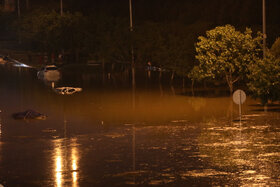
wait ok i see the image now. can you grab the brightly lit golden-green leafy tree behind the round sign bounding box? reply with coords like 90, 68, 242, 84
191, 25, 262, 93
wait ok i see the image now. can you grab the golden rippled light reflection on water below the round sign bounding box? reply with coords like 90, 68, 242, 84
198, 122, 280, 185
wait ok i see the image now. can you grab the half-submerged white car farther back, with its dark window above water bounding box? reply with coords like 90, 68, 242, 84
37, 65, 60, 82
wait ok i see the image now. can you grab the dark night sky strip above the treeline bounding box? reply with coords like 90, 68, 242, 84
30, 0, 280, 25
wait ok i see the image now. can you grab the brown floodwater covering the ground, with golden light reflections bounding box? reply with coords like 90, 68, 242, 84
0, 67, 280, 187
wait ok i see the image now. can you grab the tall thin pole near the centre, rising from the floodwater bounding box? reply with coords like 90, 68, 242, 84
129, 0, 135, 109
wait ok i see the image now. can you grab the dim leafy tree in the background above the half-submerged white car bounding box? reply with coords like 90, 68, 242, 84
21, 11, 85, 59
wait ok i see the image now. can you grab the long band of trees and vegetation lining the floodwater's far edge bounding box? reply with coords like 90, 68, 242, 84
0, 0, 280, 103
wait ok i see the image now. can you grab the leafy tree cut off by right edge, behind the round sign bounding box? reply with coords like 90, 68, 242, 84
247, 52, 280, 104
